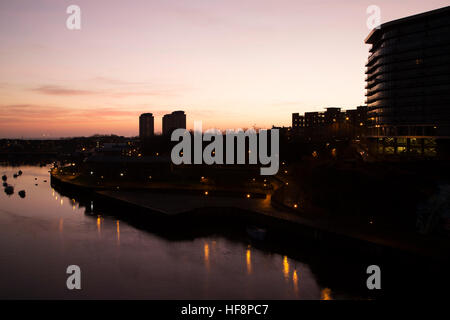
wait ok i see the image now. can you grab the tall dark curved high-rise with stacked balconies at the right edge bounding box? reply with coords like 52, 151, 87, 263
365, 7, 450, 156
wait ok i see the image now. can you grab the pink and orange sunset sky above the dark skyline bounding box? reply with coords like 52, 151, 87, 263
0, 0, 449, 138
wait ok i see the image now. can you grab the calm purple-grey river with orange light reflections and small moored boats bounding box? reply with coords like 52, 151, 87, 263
0, 166, 338, 299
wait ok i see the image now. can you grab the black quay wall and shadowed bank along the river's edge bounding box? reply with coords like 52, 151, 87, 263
51, 171, 449, 300
